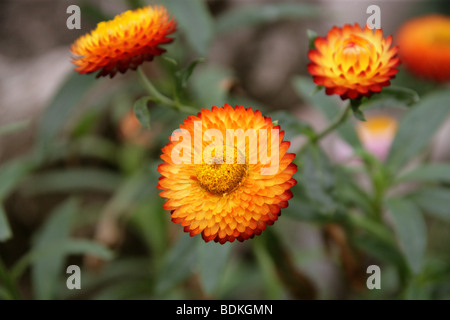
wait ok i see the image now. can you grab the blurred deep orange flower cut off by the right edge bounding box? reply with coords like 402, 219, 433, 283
397, 14, 450, 82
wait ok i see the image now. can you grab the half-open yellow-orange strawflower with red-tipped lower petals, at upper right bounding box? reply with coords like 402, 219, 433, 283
308, 24, 400, 100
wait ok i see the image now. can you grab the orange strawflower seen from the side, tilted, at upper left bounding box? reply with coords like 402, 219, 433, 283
71, 6, 176, 78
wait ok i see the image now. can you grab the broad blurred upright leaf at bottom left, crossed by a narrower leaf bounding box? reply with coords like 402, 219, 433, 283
32, 199, 79, 299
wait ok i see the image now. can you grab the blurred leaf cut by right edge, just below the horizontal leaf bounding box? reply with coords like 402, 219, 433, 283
411, 187, 450, 221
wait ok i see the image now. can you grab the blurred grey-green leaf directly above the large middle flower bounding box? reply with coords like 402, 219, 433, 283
192, 66, 231, 108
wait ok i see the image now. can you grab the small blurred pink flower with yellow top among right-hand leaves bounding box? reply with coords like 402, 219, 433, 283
356, 114, 398, 160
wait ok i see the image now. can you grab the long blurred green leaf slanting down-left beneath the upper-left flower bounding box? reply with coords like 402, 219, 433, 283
37, 72, 98, 147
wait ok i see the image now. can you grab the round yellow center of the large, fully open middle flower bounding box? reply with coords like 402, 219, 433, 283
195, 145, 248, 195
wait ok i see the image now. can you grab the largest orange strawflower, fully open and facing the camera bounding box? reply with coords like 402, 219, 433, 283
158, 104, 297, 244
